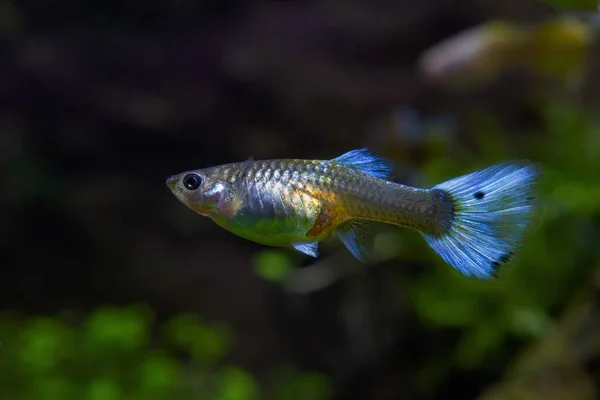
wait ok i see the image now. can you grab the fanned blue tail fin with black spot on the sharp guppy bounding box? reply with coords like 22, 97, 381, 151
423, 162, 540, 279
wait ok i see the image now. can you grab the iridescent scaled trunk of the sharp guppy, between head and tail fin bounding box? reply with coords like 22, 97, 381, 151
207, 160, 447, 242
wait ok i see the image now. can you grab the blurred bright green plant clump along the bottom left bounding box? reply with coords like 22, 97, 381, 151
0, 305, 330, 400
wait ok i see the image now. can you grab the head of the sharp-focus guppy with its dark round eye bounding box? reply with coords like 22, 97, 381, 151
166, 168, 241, 217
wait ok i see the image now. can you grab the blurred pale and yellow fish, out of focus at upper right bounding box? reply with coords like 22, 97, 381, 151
419, 16, 595, 89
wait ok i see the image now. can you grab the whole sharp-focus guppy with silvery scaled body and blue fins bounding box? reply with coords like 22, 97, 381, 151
166, 149, 540, 279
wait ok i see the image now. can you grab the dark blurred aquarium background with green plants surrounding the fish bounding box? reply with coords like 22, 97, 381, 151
0, 0, 600, 400
